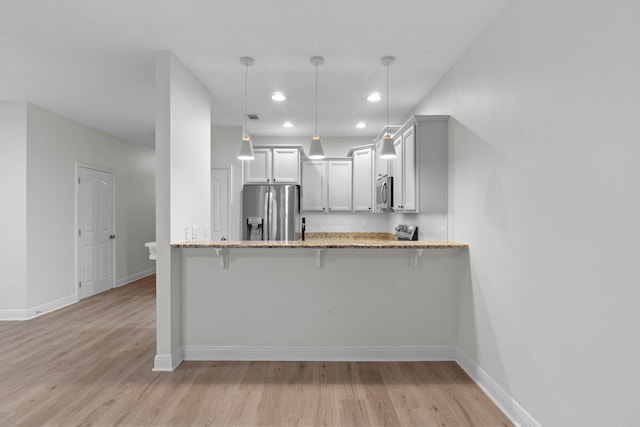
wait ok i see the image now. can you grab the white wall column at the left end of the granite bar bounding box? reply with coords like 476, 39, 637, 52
154, 52, 211, 370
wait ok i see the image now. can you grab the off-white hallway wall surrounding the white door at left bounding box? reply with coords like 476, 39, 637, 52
26, 104, 155, 307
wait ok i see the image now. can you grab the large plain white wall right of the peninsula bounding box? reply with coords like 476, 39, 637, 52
416, 0, 640, 426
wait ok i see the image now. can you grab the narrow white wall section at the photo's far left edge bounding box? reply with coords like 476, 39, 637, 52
0, 102, 27, 310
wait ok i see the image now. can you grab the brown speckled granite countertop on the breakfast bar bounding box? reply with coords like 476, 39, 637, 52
171, 232, 469, 249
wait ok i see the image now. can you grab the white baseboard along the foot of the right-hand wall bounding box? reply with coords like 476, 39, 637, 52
456, 347, 542, 427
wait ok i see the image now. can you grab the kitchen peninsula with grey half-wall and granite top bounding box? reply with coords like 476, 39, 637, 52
156, 233, 467, 370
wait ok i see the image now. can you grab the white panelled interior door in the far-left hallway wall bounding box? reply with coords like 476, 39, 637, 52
77, 166, 115, 299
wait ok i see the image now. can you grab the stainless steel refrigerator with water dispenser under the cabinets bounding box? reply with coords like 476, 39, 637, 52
242, 184, 300, 241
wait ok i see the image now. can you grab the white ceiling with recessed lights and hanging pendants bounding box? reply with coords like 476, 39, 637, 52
0, 0, 509, 147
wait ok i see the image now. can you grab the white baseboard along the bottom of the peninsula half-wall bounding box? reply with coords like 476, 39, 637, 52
183, 346, 456, 362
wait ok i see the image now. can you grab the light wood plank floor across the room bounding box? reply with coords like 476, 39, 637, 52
0, 276, 513, 427
